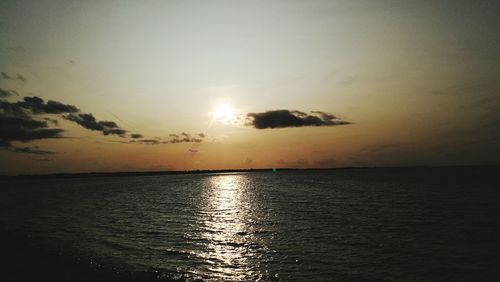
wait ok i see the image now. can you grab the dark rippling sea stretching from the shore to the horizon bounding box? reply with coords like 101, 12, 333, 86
0, 167, 500, 281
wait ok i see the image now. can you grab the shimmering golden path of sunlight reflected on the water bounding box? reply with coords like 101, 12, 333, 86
193, 174, 263, 281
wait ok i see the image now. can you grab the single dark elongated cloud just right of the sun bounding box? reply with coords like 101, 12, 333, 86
247, 110, 350, 129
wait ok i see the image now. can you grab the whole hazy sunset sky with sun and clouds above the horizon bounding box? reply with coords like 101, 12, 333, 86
0, 0, 500, 175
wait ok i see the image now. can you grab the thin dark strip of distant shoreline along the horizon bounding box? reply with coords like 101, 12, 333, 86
0, 165, 500, 180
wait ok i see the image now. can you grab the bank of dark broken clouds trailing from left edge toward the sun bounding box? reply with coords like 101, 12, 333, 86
0, 92, 206, 154
